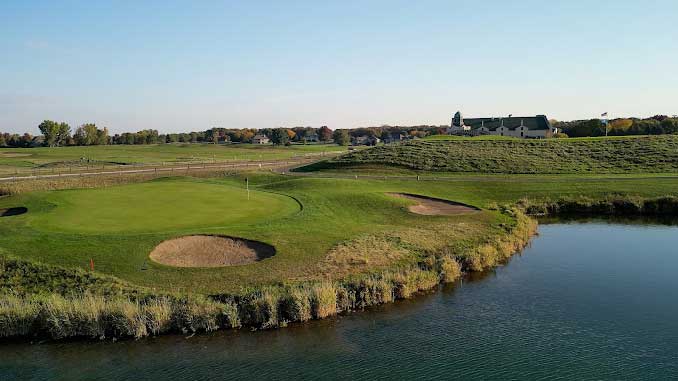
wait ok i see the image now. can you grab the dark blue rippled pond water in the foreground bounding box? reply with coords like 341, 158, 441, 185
0, 222, 678, 380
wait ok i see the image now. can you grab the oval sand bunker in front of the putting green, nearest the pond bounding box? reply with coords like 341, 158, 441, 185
150, 235, 275, 267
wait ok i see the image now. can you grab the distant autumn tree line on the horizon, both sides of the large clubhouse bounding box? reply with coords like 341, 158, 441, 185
0, 115, 678, 147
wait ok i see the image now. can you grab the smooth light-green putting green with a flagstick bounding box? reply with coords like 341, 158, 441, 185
31, 180, 299, 233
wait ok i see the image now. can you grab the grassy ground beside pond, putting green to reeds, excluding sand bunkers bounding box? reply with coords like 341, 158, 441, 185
0, 169, 678, 338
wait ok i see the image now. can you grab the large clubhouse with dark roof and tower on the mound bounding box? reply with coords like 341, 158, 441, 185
447, 111, 558, 139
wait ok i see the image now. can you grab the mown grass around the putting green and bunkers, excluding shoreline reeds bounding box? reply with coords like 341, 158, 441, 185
0, 173, 678, 293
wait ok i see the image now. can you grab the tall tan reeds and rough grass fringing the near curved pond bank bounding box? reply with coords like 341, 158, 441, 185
0, 206, 536, 339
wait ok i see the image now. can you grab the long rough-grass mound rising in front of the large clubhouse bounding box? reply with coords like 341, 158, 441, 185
302, 135, 678, 174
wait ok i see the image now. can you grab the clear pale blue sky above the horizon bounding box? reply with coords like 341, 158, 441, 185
0, 0, 678, 133
